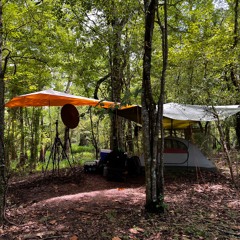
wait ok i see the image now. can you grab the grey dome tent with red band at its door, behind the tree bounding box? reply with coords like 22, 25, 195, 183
140, 137, 216, 169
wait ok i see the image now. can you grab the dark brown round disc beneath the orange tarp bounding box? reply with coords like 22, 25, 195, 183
61, 104, 79, 129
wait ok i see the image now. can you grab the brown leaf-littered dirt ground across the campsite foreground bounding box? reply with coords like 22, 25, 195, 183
0, 165, 240, 240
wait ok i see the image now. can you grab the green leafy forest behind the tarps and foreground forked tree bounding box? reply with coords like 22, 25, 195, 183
0, 0, 240, 221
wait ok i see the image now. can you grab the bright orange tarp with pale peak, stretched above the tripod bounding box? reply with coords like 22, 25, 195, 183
5, 89, 120, 108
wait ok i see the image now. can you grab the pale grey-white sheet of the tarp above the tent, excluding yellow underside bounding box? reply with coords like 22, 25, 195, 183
163, 103, 240, 121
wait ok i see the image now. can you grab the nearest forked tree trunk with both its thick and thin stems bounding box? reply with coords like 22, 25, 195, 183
142, 0, 168, 213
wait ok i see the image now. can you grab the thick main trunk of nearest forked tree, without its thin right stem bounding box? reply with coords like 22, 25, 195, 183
142, 0, 162, 212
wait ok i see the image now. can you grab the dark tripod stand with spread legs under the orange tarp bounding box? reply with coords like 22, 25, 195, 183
45, 120, 72, 174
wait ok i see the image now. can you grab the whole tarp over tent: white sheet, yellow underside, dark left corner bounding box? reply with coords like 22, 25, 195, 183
114, 103, 240, 129
